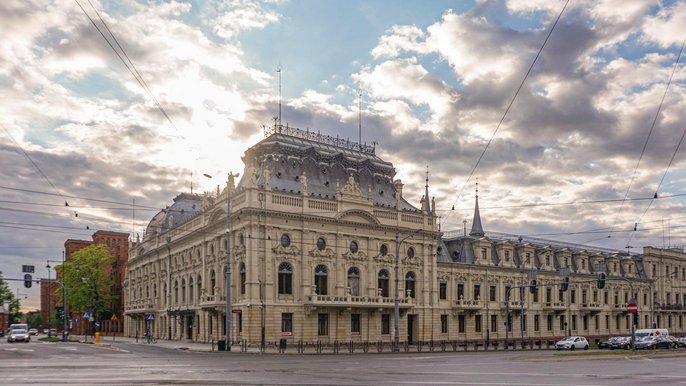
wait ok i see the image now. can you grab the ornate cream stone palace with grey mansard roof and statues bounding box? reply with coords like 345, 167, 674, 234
124, 126, 686, 345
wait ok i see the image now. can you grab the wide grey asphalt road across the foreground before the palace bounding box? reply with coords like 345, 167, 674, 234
0, 340, 686, 386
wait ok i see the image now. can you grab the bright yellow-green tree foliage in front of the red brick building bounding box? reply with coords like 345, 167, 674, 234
55, 245, 118, 320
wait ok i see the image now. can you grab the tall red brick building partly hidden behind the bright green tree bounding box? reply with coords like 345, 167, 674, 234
64, 231, 129, 335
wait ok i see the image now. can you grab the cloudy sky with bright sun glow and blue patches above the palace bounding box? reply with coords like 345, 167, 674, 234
0, 0, 686, 307
